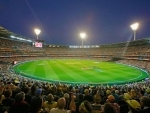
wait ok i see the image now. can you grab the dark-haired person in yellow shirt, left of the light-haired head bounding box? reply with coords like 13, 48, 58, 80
43, 94, 57, 112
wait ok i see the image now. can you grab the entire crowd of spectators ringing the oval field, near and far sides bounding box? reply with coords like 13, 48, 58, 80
0, 35, 150, 113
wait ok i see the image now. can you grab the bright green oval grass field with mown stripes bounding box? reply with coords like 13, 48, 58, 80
14, 59, 148, 84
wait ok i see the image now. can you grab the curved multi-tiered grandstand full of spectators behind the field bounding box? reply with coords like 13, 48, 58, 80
0, 26, 150, 85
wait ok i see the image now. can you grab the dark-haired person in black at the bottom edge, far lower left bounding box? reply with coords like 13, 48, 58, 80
8, 92, 30, 113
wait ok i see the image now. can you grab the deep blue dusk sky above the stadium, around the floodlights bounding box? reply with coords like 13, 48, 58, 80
0, 0, 150, 45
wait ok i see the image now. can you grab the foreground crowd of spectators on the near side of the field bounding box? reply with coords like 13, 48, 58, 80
0, 67, 150, 113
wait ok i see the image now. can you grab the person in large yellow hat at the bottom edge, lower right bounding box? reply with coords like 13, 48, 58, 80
127, 99, 141, 113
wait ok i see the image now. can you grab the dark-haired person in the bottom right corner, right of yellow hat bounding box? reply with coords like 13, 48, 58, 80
140, 96, 150, 113
